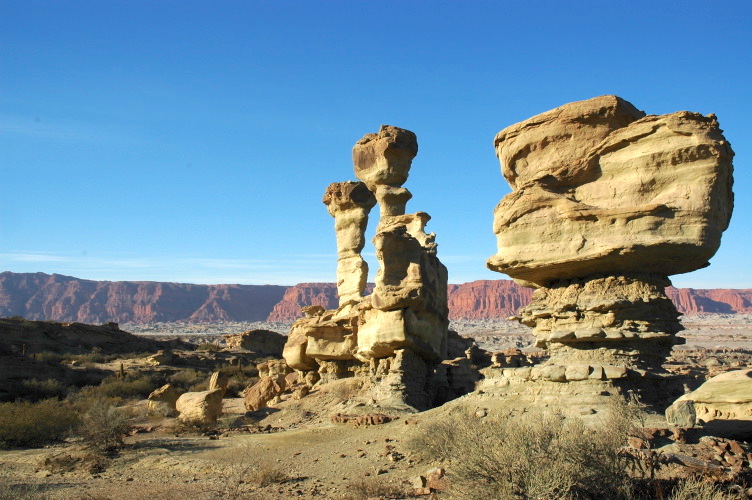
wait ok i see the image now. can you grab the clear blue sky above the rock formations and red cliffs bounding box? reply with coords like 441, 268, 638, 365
0, 0, 752, 288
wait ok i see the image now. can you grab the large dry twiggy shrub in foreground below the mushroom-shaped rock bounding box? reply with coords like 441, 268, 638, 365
410, 405, 634, 499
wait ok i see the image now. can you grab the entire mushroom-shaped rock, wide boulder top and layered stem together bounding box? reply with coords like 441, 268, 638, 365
488, 96, 734, 408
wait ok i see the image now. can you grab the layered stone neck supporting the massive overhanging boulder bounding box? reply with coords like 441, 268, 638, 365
519, 274, 683, 367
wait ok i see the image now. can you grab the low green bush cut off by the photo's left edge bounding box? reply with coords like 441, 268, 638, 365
0, 399, 79, 447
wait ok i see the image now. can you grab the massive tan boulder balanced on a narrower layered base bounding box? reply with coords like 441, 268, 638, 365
488, 96, 734, 285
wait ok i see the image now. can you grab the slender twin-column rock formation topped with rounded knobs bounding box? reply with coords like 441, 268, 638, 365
284, 125, 458, 409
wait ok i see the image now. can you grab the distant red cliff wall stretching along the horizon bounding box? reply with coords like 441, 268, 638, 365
0, 272, 752, 323
